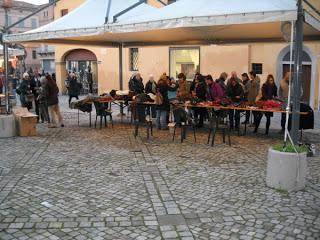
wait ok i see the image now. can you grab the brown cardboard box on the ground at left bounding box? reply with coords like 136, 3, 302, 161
12, 107, 38, 137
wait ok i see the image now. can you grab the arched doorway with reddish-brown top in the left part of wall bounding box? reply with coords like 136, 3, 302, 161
64, 49, 98, 94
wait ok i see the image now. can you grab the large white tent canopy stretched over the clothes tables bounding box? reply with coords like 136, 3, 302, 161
5, 0, 320, 46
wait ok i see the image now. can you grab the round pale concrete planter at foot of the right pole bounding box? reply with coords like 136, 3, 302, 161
266, 148, 307, 192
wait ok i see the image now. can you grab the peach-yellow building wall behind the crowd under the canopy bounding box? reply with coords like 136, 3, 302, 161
55, 0, 320, 109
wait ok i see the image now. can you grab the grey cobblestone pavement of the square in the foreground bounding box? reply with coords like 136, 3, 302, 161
0, 96, 320, 240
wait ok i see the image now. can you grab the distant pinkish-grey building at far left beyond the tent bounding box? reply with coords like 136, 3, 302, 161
0, 0, 54, 71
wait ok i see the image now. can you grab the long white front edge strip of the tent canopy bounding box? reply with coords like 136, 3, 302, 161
4, 10, 297, 42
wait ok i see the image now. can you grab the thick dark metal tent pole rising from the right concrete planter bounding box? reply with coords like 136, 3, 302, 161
291, 0, 304, 144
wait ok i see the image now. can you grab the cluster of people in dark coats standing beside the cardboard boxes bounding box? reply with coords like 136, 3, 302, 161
16, 72, 64, 128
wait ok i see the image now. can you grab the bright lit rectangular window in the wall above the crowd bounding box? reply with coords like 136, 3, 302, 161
170, 48, 200, 80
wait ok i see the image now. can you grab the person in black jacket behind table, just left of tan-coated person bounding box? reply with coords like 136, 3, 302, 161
226, 78, 244, 131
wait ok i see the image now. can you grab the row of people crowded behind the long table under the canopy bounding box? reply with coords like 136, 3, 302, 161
129, 71, 290, 134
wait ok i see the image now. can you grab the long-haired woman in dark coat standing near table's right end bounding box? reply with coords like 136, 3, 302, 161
254, 74, 278, 135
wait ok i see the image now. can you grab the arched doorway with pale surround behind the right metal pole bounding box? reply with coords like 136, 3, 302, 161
277, 46, 317, 107
